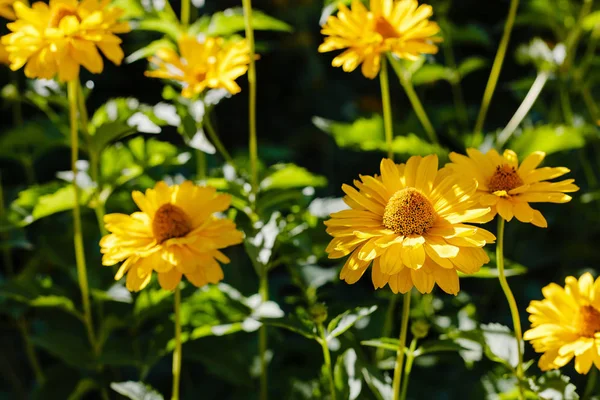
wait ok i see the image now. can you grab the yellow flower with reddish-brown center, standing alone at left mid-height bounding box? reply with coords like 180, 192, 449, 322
100, 181, 242, 291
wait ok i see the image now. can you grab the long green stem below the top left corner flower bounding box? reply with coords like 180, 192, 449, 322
68, 80, 98, 353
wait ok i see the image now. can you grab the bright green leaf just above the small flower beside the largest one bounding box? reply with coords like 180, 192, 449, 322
510, 125, 595, 157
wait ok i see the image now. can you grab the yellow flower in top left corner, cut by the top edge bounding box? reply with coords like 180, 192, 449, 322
2, 0, 130, 82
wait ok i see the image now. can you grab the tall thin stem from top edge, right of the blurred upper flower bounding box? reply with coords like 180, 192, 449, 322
242, 0, 258, 194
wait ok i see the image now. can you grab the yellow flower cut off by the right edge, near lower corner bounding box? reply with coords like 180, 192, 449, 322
524, 272, 600, 374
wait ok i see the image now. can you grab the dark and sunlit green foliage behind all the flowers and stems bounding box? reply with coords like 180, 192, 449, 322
0, 0, 600, 399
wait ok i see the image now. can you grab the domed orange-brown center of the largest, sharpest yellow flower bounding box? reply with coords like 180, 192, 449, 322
383, 188, 436, 236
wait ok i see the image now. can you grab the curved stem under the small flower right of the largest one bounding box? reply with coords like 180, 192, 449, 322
496, 216, 525, 400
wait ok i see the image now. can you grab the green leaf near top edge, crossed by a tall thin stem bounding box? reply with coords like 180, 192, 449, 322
206, 7, 292, 36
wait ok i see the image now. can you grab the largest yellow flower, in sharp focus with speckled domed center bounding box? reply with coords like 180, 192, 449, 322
325, 155, 495, 294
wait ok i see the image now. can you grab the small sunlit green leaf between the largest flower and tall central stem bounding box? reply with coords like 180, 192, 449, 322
260, 164, 327, 191
